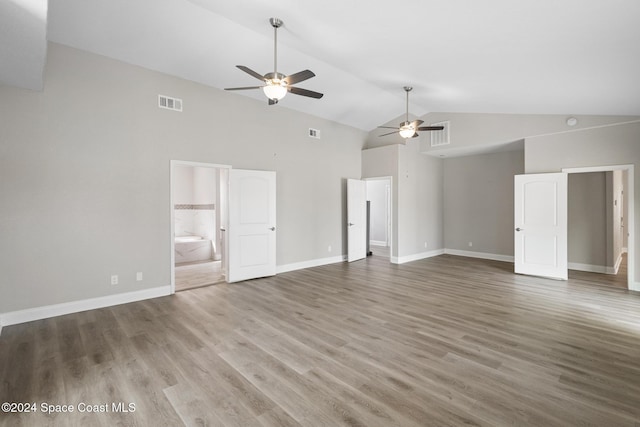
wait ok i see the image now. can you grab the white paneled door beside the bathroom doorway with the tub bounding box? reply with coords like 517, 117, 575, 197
227, 169, 276, 282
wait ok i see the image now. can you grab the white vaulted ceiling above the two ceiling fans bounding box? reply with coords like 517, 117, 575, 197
10, 0, 640, 130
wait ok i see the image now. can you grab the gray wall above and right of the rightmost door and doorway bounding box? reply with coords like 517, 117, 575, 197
525, 123, 640, 287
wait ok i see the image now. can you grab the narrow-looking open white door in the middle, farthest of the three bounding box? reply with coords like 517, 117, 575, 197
347, 179, 367, 262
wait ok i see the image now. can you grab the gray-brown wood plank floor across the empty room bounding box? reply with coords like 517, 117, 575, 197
0, 255, 640, 427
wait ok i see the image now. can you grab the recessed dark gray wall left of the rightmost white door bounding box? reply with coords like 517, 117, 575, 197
444, 151, 524, 256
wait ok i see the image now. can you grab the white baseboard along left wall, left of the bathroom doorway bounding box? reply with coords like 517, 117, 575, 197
0, 286, 171, 326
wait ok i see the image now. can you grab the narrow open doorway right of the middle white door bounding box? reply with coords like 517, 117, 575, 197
364, 176, 392, 260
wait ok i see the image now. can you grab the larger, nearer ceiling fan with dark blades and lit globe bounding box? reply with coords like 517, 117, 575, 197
225, 18, 323, 105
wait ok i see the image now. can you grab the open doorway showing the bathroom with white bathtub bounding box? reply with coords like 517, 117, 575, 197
170, 160, 230, 293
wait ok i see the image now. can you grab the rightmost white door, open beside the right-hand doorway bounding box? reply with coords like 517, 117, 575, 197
514, 173, 567, 280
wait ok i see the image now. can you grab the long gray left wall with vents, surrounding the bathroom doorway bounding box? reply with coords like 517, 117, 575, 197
0, 44, 366, 313
